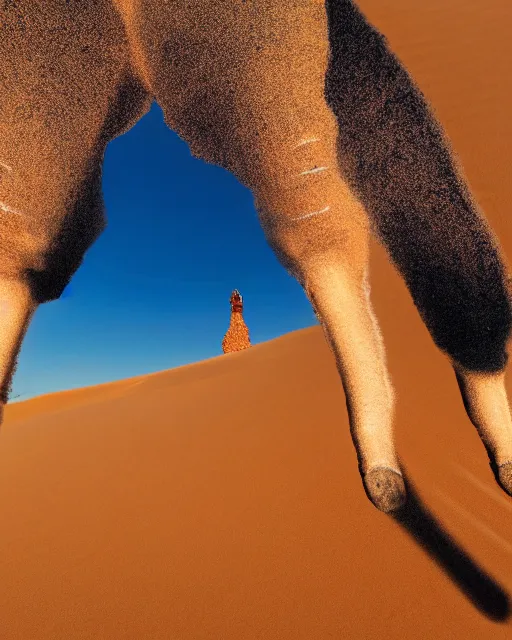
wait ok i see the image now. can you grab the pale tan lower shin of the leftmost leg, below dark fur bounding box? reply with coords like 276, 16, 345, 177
0, 279, 37, 424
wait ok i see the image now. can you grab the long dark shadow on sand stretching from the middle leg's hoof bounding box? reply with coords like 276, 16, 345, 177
391, 467, 510, 622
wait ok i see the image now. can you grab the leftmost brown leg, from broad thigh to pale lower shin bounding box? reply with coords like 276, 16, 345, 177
0, 0, 151, 430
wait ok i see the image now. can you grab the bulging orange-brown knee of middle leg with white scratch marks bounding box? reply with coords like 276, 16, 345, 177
251, 128, 369, 281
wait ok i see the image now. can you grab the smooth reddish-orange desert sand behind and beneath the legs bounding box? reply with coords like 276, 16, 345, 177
0, 0, 512, 640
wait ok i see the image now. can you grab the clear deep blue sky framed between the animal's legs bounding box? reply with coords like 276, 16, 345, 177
12, 104, 317, 401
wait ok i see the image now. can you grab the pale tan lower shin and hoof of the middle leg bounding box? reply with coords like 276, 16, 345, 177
304, 261, 405, 512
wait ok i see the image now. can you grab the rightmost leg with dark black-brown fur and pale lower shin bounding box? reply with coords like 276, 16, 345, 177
326, 0, 512, 494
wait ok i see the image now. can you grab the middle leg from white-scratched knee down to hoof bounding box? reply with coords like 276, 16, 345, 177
253, 126, 405, 512
